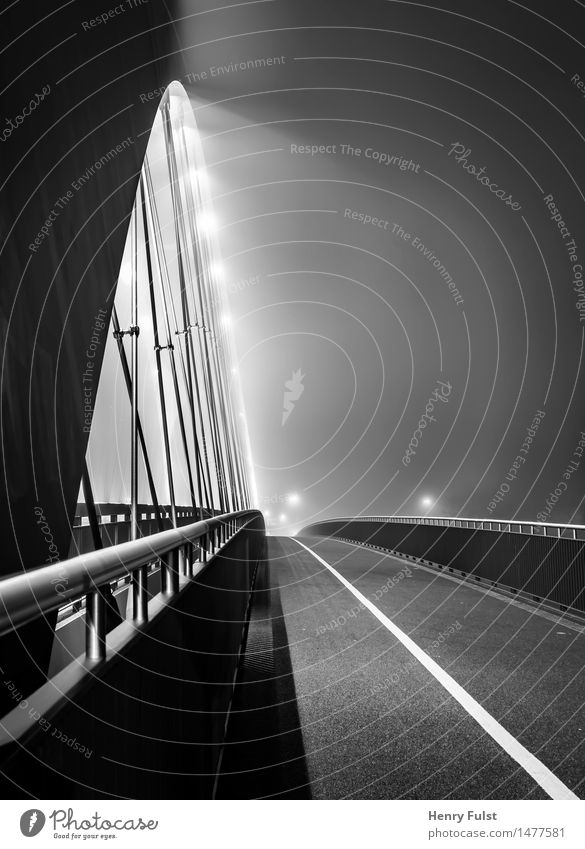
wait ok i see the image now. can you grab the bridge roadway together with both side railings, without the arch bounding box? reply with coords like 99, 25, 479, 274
0, 510, 585, 800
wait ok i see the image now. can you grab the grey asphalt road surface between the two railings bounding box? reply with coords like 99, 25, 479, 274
217, 538, 585, 799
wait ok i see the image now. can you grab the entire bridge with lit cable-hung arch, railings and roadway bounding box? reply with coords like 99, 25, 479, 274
0, 4, 585, 800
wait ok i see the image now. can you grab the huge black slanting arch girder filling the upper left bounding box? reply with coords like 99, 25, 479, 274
0, 0, 182, 708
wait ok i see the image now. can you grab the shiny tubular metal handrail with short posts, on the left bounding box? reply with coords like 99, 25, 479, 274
0, 510, 262, 660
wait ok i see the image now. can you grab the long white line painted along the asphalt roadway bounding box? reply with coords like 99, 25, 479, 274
291, 537, 579, 801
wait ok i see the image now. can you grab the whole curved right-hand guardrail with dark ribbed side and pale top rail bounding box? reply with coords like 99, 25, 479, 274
300, 516, 585, 617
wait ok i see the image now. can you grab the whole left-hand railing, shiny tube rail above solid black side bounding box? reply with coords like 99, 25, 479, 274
0, 510, 265, 799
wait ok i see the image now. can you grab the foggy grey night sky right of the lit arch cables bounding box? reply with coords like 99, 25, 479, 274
171, 0, 585, 531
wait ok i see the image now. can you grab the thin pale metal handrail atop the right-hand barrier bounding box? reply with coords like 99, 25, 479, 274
301, 516, 585, 539
